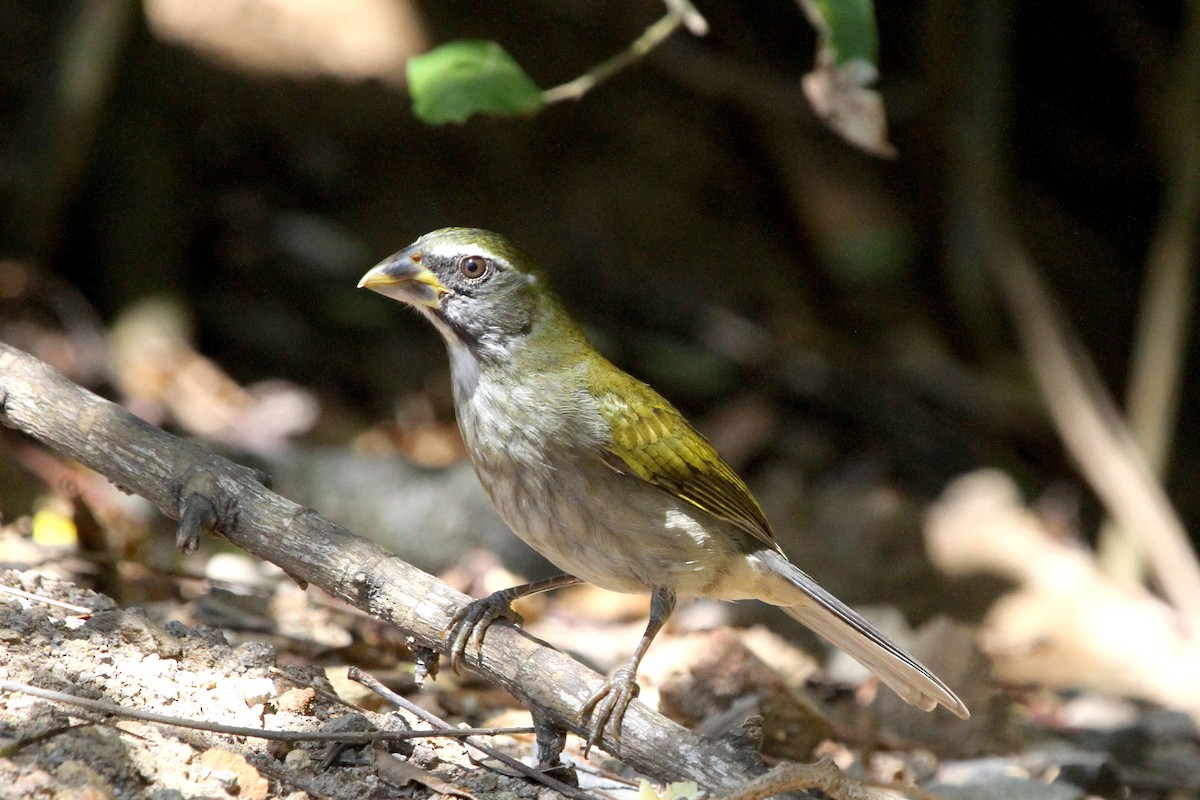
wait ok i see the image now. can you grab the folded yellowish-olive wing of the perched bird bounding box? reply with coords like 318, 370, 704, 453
598, 379, 779, 549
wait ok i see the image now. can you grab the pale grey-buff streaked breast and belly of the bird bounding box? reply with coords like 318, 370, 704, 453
456, 380, 731, 595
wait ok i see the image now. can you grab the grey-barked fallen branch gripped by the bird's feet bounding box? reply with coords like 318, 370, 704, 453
0, 343, 766, 792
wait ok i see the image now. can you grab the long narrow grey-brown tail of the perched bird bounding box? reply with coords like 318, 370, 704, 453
757, 551, 971, 720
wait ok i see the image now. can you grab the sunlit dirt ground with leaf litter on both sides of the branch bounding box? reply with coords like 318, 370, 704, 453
0, 532, 1200, 800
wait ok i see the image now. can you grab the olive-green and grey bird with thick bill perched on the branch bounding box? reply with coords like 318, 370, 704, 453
359, 228, 970, 748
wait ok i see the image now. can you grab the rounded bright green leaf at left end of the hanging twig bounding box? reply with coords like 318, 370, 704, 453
406, 40, 545, 125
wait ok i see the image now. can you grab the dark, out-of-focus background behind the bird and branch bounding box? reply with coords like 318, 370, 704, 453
0, 0, 1200, 786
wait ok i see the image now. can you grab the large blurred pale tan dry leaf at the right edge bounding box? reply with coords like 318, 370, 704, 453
925, 470, 1200, 720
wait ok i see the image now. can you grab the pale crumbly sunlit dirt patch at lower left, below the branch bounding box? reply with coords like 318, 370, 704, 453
0, 572, 573, 800
